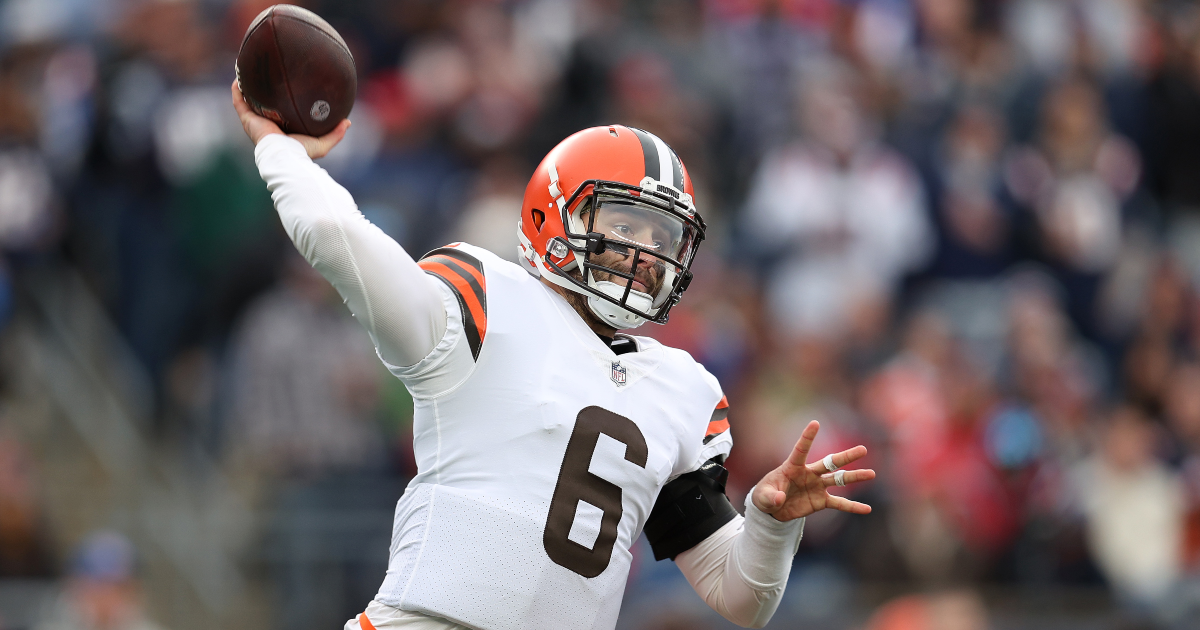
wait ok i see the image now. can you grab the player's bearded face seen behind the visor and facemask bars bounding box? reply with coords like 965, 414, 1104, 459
582, 200, 688, 296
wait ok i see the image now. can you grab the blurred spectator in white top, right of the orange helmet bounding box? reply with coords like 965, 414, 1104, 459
743, 58, 932, 340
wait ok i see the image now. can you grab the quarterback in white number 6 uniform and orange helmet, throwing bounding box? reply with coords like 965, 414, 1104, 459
233, 82, 875, 630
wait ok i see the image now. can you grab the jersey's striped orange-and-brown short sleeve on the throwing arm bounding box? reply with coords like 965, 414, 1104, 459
388, 244, 487, 398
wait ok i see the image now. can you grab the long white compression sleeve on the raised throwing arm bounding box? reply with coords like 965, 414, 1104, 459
254, 133, 446, 366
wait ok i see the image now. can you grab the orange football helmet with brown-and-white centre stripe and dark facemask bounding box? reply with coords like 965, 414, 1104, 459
517, 125, 704, 329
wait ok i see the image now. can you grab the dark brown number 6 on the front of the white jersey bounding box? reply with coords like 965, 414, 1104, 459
541, 407, 647, 577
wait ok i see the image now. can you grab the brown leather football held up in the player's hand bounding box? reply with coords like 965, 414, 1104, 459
234, 5, 358, 136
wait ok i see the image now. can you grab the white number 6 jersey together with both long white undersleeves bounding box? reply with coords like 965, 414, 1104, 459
254, 134, 804, 630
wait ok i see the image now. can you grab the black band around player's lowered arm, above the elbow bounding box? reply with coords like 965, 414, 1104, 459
646, 458, 738, 560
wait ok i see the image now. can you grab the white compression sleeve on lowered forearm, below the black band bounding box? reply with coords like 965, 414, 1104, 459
676, 497, 804, 628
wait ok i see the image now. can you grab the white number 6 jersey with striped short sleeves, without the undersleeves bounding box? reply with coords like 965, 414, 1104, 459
377, 244, 732, 630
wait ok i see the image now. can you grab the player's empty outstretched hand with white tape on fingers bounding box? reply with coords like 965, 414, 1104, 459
751, 420, 875, 521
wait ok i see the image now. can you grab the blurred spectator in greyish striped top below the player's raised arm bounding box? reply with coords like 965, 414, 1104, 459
228, 256, 382, 478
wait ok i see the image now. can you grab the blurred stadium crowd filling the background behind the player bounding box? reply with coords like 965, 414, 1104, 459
0, 0, 1200, 630
